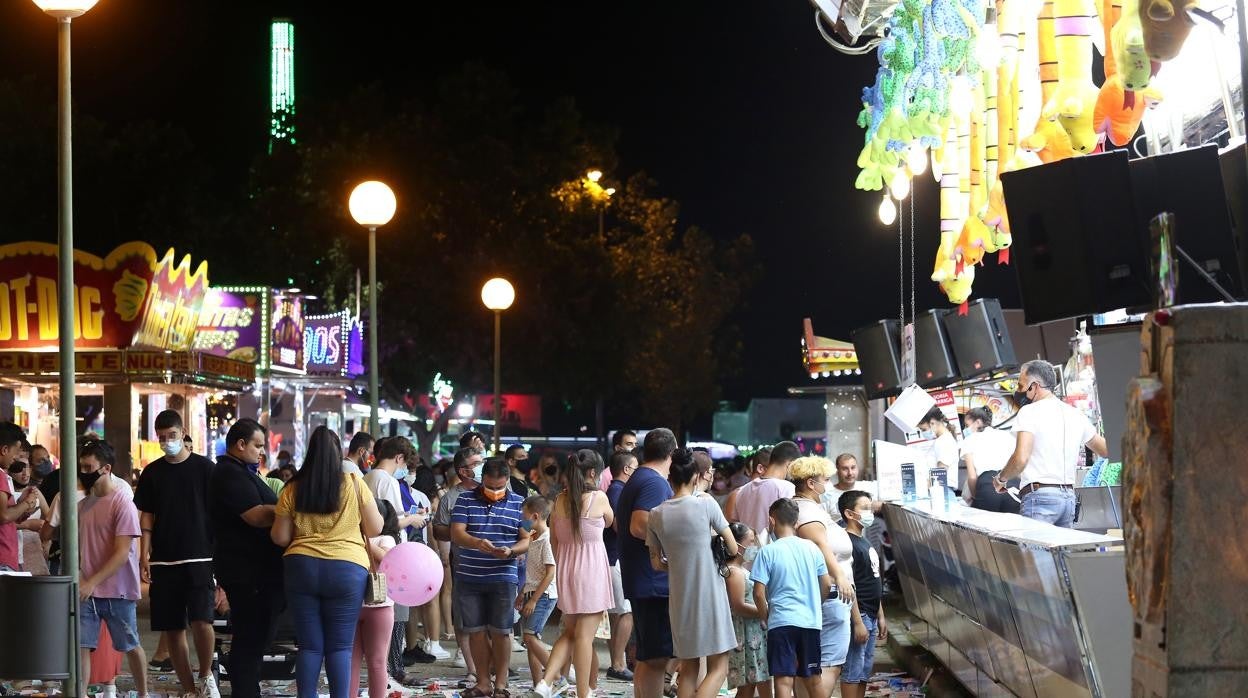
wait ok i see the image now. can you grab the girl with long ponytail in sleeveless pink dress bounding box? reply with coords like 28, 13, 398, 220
533, 448, 615, 698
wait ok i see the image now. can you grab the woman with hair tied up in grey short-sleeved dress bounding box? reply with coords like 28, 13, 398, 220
646, 448, 736, 698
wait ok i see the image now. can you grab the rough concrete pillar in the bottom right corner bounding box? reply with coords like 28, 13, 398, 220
1128, 303, 1248, 698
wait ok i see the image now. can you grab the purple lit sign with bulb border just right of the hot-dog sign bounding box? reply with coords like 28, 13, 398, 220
195, 286, 270, 368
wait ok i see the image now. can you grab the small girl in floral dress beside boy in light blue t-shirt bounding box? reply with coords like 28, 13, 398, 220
711, 523, 771, 698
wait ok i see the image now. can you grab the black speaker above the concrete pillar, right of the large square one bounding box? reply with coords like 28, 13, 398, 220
1131, 145, 1243, 303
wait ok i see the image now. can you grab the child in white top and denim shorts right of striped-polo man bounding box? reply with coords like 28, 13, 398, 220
515, 494, 559, 683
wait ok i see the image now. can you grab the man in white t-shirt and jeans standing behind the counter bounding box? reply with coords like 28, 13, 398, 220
992, 360, 1109, 528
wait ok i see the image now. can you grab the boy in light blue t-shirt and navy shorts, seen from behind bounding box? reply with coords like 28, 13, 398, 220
750, 498, 832, 698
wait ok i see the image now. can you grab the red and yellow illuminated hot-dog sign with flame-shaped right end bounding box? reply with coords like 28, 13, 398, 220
0, 242, 207, 350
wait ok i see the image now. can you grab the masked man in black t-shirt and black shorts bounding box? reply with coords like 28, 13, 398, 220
135, 410, 220, 698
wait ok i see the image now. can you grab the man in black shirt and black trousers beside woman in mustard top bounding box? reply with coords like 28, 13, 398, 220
210, 418, 286, 698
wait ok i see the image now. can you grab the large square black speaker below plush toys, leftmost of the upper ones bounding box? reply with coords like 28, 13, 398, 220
1003, 150, 1153, 324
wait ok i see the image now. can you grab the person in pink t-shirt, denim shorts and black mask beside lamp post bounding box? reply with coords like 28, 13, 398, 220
77, 440, 147, 697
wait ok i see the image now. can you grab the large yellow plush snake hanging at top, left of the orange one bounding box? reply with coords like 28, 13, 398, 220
1042, 0, 1099, 155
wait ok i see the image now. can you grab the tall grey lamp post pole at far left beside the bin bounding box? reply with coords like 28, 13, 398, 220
56, 17, 84, 696
